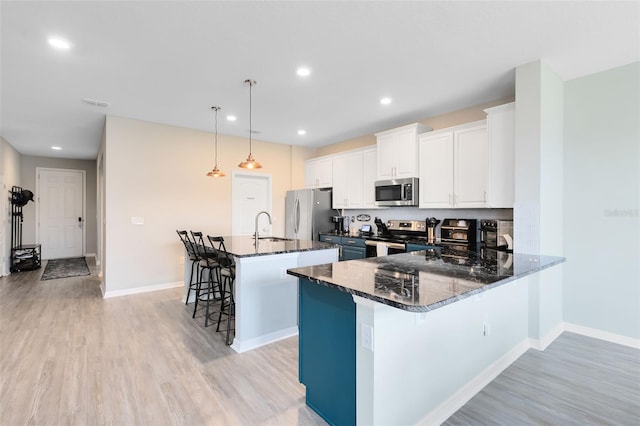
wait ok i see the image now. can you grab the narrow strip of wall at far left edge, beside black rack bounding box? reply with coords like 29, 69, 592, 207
0, 138, 21, 277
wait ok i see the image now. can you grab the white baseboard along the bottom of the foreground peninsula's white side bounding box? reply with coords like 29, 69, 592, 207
418, 339, 529, 425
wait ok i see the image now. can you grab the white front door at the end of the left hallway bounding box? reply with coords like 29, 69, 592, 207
36, 169, 84, 259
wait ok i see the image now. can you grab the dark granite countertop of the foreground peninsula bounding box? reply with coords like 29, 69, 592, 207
287, 247, 565, 312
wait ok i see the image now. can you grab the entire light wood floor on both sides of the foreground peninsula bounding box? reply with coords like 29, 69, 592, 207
0, 265, 640, 426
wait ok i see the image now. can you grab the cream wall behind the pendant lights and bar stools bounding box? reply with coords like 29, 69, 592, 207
103, 116, 312, 292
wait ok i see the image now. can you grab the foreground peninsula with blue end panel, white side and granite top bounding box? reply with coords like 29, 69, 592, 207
288, 248, 564, 425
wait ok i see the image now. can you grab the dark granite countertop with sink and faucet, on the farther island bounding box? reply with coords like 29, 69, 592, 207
224, 235, 337, 258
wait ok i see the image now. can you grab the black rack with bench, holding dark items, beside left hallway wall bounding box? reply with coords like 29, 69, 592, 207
9, 186, 42, 272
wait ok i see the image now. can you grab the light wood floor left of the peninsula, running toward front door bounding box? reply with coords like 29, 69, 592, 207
0, 260, 325, 426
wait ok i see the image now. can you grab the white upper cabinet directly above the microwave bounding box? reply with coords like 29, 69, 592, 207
376, 123, 431, 180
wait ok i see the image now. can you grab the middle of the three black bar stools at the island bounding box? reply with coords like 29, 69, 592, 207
191, 231, 222, 327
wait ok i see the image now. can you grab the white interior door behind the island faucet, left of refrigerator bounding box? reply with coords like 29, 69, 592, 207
231, 172, 271, 235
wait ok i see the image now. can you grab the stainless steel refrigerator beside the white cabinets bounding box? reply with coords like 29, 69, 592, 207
284, 189, 333, 241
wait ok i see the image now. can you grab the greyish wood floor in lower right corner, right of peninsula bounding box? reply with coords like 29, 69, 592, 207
445, 333, 640, 426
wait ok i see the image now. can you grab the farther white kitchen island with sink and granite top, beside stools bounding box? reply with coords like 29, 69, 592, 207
185, 236, 338, 352
